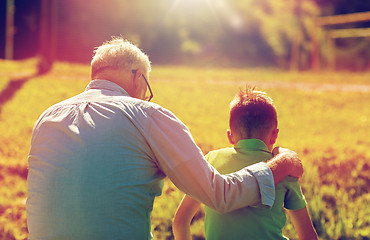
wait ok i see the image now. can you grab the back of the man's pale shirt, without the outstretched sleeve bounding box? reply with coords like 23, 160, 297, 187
27, 80, 164, 240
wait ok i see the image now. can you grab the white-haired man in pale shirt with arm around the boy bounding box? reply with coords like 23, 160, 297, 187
27, 38, 303, 240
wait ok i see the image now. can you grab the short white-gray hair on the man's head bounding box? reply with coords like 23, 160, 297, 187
91, 37, 151, 77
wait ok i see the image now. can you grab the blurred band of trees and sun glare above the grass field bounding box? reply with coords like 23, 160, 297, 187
0, 0, 370, 71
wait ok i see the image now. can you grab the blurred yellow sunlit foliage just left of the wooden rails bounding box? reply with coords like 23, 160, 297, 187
254, 0, 320, 68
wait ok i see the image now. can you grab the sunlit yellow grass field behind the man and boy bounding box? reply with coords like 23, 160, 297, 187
0, 60, 370, 240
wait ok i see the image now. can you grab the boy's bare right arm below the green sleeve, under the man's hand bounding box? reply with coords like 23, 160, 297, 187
288, 207, 318, 240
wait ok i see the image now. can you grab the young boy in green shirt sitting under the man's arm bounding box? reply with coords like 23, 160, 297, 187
172, 87, 317, 240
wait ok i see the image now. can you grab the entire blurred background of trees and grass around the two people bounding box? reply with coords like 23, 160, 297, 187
0, 0, 370, 240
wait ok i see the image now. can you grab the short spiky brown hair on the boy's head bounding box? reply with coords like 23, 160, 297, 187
229, 85, 277, 139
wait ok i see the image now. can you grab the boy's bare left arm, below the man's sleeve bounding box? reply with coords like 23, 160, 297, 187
172, 195, 200, 240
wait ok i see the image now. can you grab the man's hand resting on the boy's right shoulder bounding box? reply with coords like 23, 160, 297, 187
267, 147, 303, 184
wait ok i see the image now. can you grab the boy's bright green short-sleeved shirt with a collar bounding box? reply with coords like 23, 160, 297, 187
205, 139, 306, 240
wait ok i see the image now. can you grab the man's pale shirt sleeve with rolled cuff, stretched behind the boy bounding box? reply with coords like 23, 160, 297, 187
147, 108, 275, 213
